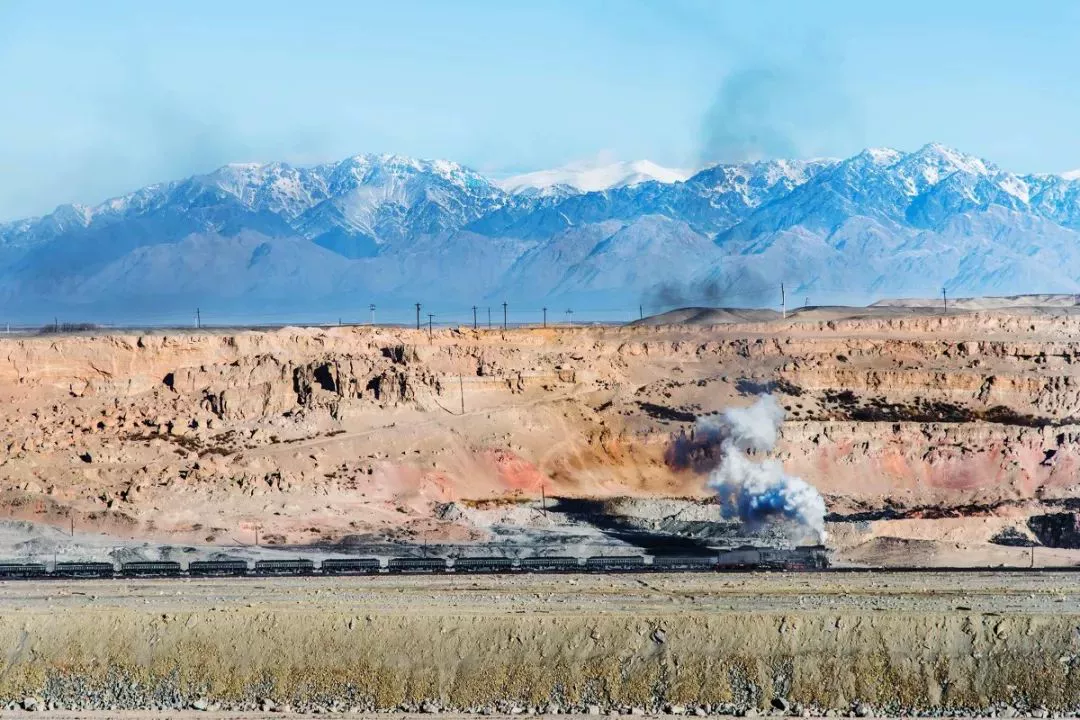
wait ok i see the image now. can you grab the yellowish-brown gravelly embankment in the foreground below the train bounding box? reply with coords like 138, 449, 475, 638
6, 573, 1080, 715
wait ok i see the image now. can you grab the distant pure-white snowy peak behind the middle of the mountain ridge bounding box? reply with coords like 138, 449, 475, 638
496, 160, 692, 192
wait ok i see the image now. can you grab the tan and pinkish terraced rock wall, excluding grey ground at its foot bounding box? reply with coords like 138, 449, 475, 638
6, 313, 1080, 548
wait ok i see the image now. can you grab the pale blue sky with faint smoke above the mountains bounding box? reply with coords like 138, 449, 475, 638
0, 0, 1080, 219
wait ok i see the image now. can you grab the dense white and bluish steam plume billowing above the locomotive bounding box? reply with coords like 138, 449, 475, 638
694, 395, 825, 543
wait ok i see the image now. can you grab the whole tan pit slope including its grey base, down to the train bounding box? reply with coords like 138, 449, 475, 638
0, 301, 1080, 566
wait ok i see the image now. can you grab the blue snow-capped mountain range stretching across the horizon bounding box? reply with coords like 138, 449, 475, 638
0, 144, 1080, 322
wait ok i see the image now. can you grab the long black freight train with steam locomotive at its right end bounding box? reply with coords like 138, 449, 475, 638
0, 545, 828, 580
